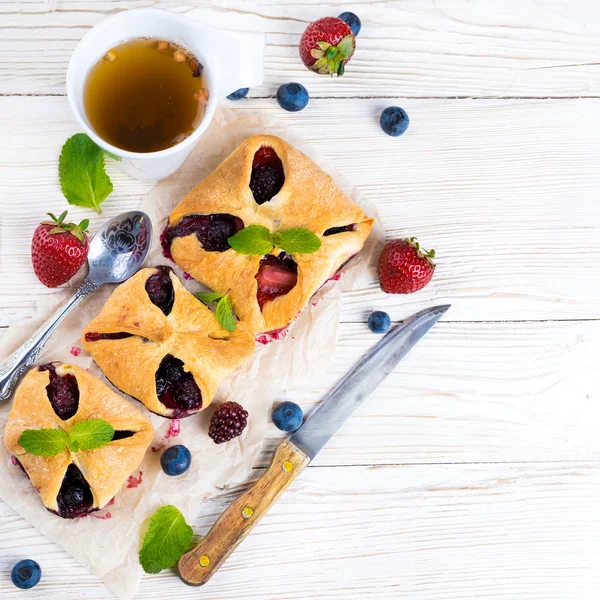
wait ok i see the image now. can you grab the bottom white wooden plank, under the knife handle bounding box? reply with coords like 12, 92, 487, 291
0, 463, 600, 600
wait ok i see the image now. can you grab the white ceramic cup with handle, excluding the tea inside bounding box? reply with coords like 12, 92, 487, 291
67, 8, 265, 182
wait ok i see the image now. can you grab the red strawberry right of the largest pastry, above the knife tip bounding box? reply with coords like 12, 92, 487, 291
377, 238, 435, 294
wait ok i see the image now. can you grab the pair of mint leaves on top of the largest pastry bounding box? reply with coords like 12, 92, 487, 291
227, 225, 321, 255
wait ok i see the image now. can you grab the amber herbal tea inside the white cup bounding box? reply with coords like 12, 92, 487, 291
84, 39, 208, 152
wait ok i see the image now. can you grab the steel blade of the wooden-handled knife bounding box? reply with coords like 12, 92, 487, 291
290, 305, 450, 460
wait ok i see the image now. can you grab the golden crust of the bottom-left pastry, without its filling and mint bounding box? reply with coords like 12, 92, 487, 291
4, 363, 154, 512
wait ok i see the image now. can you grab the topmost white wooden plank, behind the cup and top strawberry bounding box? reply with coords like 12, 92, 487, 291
0, 0, 600, 97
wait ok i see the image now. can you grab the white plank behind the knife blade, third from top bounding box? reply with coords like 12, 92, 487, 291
258, 322, 600, 466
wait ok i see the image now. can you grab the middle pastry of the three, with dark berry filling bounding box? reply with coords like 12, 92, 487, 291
82, 267, 254, 418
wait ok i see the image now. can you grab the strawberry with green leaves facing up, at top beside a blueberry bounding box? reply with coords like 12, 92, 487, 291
300, 17, 356, 76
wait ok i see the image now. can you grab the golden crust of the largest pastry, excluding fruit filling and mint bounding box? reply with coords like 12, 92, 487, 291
169, 135, 373, 332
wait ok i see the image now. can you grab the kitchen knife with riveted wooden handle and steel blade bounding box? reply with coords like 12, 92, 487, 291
178, 305, 450, 585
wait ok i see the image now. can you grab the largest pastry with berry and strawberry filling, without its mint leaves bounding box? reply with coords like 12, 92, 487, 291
161, 135, 373, 332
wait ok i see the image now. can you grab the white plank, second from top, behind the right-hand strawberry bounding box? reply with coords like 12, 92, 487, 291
0, 97, 600, 325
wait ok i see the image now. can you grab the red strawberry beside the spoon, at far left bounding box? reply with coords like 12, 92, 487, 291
31, 210, 89, 287
